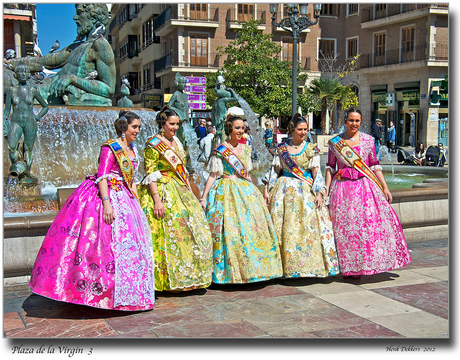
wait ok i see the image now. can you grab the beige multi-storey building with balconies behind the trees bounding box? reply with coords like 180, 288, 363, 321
109, 3, 448, 145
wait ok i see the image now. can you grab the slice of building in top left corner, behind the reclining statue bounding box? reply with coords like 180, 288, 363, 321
3, 4, 37, 57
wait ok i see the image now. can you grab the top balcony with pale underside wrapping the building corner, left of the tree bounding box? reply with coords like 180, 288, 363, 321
155, 5, 219, 36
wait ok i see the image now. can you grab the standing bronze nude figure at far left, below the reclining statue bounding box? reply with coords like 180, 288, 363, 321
3, 64, 48, 182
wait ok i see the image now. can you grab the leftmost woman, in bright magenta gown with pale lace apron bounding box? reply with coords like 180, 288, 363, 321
29, 110, 155, 311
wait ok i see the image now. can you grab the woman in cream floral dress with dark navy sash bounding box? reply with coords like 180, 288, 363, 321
264, 114, 339, 278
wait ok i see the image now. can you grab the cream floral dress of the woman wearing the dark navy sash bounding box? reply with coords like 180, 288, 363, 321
270, 143, 339, 278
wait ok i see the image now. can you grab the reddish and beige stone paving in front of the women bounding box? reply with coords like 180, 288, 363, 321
3, 239, 449, 339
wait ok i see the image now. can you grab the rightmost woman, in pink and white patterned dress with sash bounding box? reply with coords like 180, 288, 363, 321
326, 108, 411, 279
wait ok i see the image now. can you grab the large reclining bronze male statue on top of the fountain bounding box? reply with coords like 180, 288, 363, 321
4, 3, 116, 106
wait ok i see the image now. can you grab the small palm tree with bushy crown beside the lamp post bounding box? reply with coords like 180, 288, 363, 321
307, 78, 343, 134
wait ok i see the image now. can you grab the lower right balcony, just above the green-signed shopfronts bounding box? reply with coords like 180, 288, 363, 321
358, 44, 449, 69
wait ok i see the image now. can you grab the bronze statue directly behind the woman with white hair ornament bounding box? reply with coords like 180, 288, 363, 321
211, 73, 238, 147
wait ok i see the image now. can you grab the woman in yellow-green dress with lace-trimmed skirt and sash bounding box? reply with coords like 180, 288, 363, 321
139, 106, 212, 291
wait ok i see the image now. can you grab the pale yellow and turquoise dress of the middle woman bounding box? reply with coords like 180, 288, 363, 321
206, 145, 283, 284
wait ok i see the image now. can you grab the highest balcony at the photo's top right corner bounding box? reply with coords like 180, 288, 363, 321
361, 4, 449, 29
